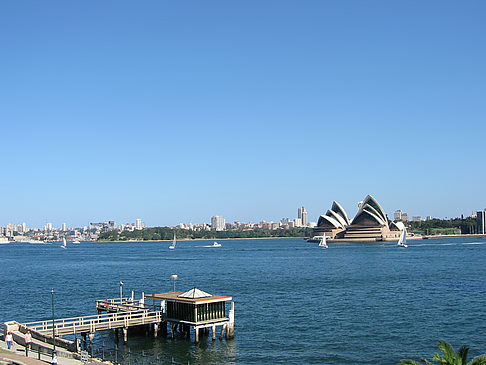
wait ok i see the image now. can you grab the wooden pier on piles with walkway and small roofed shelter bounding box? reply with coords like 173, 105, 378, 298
4, 288, 234, 357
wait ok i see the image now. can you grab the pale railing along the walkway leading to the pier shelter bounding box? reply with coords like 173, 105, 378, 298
23, 310, 162, 336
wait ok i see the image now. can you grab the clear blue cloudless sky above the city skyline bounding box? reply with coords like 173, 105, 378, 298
0, 0, 486, 226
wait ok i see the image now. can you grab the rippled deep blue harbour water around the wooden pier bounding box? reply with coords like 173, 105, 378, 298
0, 238, 486, 364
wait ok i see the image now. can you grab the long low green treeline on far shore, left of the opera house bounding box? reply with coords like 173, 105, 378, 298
98, 227, 312, 241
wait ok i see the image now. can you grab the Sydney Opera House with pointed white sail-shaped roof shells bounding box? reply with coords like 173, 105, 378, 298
313, 195, 401, 241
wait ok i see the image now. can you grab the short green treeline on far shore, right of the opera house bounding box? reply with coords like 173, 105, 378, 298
407, 218, 476, 235
